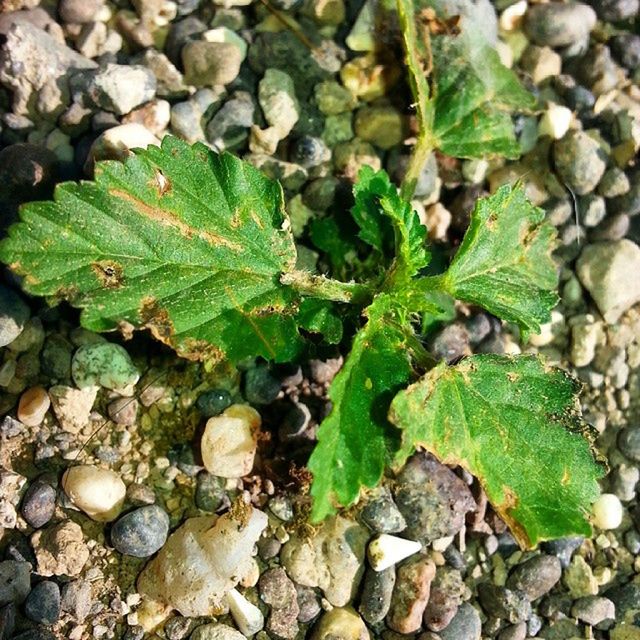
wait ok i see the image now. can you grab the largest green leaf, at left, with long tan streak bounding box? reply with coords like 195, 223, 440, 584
0, 137, 301, 361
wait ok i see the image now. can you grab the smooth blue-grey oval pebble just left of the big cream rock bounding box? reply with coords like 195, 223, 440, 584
111, 504, 169, 558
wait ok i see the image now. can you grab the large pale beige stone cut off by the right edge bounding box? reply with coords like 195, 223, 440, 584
577, 239, 640, 324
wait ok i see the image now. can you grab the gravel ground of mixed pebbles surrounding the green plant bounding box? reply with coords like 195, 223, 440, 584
0, 0, 640, 640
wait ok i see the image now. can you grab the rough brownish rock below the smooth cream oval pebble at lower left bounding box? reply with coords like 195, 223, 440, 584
31, 521, 89, 576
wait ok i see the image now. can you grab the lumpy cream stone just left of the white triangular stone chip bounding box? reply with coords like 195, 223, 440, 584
280, 516, 369, 607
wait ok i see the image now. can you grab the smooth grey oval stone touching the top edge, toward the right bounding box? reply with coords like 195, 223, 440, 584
524, 2, 596, 47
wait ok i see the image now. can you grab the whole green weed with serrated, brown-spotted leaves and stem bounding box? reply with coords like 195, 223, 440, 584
0, 0, 603, 546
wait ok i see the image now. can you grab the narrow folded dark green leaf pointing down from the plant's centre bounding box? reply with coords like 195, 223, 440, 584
309, 295, 411, 522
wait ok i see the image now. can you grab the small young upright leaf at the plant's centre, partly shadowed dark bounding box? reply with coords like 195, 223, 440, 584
351, 166, 429, 281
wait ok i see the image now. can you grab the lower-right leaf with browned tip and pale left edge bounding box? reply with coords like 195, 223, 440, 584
390, 355, 604, 547
